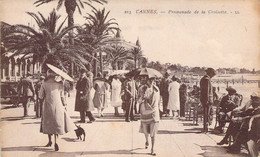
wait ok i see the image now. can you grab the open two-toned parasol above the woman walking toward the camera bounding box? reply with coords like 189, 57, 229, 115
126, 68, 162, 78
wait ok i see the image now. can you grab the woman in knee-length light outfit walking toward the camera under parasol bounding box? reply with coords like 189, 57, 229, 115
139, 78, 160, 155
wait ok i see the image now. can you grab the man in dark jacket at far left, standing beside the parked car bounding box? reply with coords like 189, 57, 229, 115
18, 72, 35, 117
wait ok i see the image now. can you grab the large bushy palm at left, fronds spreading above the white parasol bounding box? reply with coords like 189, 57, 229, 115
5, 10, 92, 70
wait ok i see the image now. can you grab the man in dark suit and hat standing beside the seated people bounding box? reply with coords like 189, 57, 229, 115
200, 68, 216, 132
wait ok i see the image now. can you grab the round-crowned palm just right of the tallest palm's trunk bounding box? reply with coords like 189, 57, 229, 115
80, 8, 118, 75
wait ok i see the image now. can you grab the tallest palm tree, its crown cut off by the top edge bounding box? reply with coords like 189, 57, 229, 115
34, 0, 107, 44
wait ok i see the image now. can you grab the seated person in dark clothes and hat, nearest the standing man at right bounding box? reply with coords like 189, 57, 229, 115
216, 86, 241, 133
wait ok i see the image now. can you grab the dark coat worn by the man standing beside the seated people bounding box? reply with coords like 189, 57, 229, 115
200, 75, 213, 106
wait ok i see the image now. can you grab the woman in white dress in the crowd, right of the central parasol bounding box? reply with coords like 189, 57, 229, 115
167, 76, 180, 117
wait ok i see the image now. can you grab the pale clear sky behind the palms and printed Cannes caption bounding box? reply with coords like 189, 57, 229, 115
0, 0, 260, 70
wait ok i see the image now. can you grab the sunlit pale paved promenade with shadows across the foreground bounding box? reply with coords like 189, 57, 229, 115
0, 90, 252, 157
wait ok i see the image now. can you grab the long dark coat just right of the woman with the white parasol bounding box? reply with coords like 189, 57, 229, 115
75, 77, 94, 111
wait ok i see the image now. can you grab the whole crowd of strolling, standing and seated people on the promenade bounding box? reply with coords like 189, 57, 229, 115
14, 65, 260, 156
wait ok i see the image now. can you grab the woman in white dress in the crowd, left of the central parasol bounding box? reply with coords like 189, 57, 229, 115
111, 76, 122, 116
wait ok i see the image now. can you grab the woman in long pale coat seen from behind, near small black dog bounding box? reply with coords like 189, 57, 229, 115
39, 70, 74, 151
